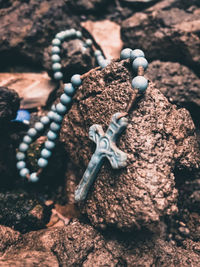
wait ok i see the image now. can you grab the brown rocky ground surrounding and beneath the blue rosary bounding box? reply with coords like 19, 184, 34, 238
0, 0, 200, 267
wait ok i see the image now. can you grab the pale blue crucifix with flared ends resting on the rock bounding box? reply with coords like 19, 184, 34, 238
75, 112, 128, 202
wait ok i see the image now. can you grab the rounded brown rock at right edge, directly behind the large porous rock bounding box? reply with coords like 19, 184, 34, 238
147, 60, 200, 124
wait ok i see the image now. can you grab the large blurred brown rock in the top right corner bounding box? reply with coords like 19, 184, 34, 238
121, 1, 200, 73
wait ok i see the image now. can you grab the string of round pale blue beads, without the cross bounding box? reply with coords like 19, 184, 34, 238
16, 29, 148, 182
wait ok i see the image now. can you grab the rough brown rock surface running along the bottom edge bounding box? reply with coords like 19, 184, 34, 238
0, 221, 200, 267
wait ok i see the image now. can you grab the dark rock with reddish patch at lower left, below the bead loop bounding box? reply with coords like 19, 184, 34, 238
0, 191, 50, 233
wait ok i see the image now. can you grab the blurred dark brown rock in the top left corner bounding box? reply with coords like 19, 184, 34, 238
0, 0, 80, 71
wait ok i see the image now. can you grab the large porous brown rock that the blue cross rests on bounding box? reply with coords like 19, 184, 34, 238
60, 60, 199, 230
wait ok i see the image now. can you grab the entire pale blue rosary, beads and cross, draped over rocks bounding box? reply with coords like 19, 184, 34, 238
16, 29, 148, 202
